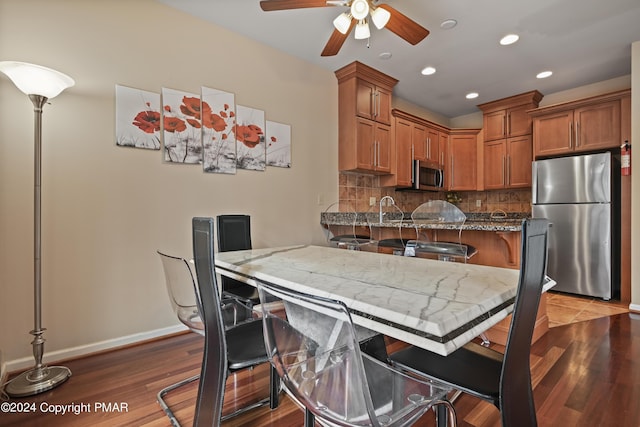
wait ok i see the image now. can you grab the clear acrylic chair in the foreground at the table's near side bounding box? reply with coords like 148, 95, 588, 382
258, 284, 455, 427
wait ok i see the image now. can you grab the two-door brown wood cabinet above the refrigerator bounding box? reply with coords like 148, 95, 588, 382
529, 90, 630, 158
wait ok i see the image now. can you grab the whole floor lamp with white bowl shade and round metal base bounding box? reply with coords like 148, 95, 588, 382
0, 61, 75, 397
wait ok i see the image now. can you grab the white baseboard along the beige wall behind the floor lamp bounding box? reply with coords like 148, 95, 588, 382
6, 325, 187, 372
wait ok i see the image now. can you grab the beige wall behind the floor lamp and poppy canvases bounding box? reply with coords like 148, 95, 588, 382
0, 0, 338, 368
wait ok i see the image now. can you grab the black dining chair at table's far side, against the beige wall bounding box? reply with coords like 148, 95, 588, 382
216, 214, 260, 307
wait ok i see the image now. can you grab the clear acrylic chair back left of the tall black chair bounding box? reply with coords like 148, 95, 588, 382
158, 251, 204, 335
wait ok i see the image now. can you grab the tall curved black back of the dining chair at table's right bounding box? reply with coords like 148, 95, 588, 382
500, 218, 549, 427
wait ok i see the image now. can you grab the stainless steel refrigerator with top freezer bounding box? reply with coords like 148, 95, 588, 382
531, 153, 620, 300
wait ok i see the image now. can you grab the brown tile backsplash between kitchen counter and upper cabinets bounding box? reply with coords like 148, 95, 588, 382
338, 172, 531, 214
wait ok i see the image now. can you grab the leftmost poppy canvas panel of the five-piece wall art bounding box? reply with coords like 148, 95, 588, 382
116, 85, 162, 150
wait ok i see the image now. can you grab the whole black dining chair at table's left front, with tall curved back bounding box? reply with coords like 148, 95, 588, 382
192, 218, 280, 426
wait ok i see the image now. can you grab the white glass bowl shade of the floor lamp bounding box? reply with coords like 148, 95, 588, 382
0, 61, 75, 99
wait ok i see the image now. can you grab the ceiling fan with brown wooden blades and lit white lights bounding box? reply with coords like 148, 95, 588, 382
260, 0, 429, 56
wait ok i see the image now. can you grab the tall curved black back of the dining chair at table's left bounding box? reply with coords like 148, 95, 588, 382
192, 218, 228, 426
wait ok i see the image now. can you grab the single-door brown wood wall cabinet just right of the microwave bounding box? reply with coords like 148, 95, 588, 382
445, 129, 480, 191
